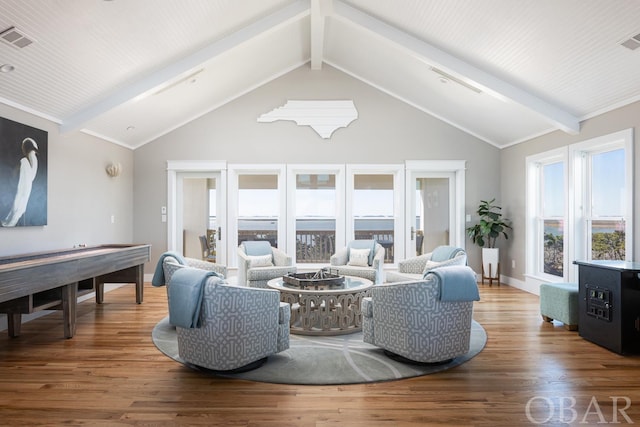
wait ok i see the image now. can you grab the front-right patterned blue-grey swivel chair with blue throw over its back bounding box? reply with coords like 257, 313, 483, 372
362, 266, 480, 363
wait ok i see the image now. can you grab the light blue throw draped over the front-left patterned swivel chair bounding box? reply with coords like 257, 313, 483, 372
169, 267, 218, 328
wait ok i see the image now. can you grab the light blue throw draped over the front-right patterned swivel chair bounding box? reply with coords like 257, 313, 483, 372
425, 265, 480, 301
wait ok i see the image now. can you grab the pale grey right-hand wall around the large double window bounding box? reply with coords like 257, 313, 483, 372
500, 98, 640, 285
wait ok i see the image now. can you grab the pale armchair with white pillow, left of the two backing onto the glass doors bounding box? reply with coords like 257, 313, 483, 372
238, 241, 296, 288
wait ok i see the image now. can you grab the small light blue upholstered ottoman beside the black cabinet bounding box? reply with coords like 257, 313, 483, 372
540, 283, 578, 331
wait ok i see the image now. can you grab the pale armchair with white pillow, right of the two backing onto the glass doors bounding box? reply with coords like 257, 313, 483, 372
329, 240, 385, 284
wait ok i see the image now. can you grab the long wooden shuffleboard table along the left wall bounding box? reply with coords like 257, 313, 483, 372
0, 244, 151, 338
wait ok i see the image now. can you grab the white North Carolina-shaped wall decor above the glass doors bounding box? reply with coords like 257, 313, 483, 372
258, 101, 358, 139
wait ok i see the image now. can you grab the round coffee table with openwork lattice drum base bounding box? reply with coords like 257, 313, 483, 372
267, 276, 373, 335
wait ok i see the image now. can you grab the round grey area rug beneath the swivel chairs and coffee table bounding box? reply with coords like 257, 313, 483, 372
152, 316, 487, 385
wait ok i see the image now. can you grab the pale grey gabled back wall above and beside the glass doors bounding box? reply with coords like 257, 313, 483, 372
134, 65, 500, 272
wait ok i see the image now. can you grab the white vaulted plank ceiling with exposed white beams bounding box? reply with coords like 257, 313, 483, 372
0, 0, 640, 148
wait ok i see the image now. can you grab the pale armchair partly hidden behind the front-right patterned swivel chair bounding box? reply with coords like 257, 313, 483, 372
385, 246, 467, 283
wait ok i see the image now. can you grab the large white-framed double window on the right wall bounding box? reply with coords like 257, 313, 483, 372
526, 129, 633, 282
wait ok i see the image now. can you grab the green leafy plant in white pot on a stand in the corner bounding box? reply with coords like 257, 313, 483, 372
467, 198, 511, 279
